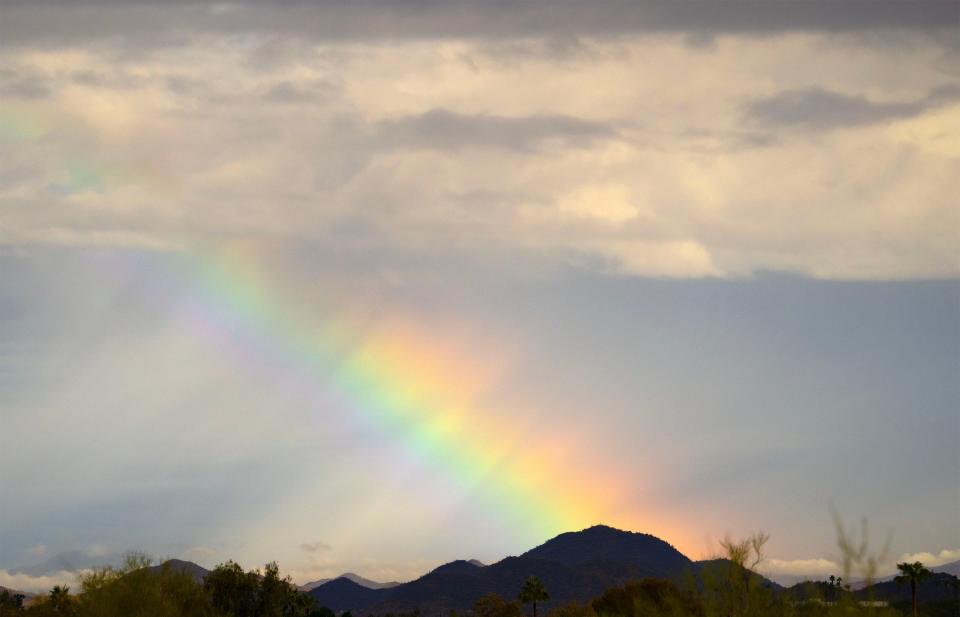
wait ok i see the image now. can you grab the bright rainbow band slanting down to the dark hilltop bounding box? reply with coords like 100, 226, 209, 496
150, 247, 621, 537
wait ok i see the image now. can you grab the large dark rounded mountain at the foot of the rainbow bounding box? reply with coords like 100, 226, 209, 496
310, 525, 696, 614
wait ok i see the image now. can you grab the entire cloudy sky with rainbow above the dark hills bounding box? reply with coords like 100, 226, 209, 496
0, 0, 960, 590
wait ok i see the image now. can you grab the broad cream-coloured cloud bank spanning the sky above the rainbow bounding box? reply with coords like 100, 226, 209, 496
0, 35, 948, 279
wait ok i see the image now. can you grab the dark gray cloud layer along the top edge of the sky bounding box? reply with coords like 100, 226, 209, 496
0, 0, 960, 44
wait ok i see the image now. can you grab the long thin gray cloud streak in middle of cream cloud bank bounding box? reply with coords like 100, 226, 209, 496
377, 109, 617, 151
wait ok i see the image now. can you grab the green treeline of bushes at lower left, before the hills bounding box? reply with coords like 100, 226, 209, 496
0, 555, 335, 617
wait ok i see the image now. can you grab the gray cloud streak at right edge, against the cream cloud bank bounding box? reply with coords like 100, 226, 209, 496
746, 84, 960, 129
